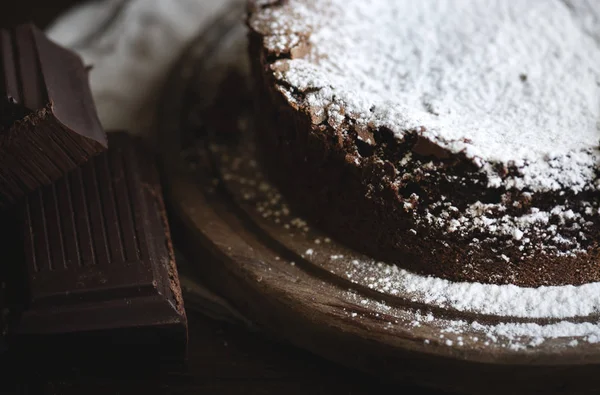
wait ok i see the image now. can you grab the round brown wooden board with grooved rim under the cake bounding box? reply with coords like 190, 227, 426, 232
159, 6, 600, 394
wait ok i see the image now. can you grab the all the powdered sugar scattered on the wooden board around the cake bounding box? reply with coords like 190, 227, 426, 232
211, 139, 600, 351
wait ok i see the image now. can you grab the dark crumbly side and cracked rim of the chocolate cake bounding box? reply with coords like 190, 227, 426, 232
248, 0, 600, 286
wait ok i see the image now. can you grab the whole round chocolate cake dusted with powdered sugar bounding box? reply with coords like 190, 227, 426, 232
248, 0, 600, 286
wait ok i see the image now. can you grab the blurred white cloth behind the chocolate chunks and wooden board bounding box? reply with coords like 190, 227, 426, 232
48, 0, 232, 141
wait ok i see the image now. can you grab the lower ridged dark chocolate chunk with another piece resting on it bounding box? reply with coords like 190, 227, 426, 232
9, 133, 187, 366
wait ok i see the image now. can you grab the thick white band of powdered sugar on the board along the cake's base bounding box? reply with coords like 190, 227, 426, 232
344, 260, 600, 319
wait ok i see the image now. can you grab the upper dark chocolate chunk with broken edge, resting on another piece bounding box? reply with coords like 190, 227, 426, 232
0, 24, 107, 208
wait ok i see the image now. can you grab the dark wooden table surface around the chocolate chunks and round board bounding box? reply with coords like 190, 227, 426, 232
0, 0, 448, 395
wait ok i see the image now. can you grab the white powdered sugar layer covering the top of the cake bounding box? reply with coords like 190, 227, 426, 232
250, 0, 600, 192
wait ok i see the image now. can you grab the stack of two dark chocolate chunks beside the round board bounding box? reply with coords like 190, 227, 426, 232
0, 25, 187, 366
